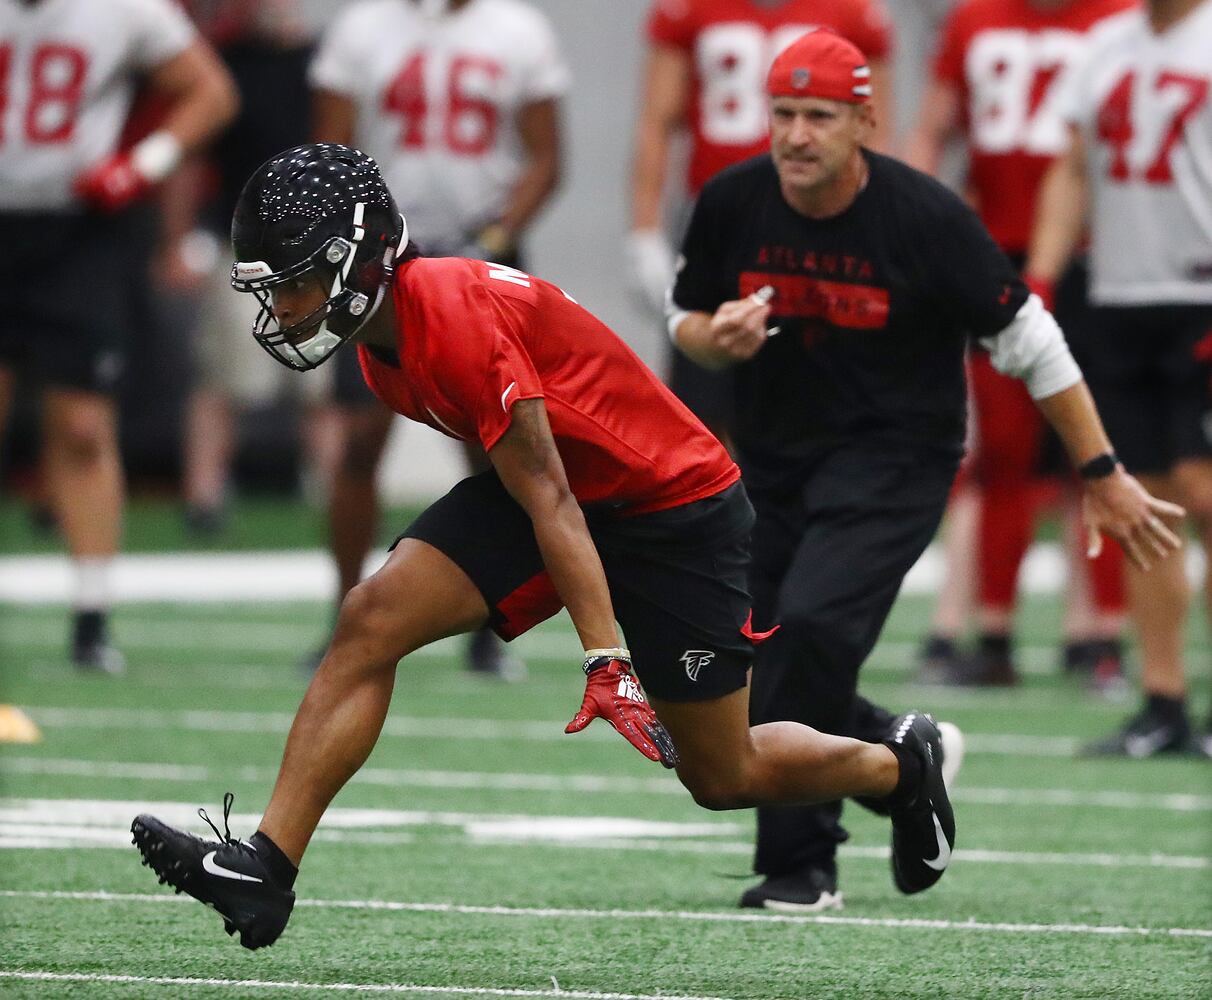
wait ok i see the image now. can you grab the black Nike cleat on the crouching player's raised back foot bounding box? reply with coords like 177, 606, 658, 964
887, 713, 955, 893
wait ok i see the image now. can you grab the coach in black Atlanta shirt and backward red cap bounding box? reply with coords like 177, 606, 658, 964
669, 30, 1183, 909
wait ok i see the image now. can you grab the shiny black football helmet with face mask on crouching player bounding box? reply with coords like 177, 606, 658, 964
231, 143, 408, 371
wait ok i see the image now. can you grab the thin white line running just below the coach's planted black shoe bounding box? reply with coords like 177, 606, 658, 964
0, 890, 1212, 935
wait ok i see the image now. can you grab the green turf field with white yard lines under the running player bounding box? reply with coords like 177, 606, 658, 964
0, 511, 1212, 1000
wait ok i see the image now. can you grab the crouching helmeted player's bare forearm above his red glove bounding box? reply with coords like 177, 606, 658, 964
530, 491, 621, 650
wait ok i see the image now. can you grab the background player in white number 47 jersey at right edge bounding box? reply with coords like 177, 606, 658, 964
1028, 0, 1212, 756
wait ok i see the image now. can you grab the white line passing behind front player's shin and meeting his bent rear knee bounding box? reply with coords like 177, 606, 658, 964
5, 756, 1212, 812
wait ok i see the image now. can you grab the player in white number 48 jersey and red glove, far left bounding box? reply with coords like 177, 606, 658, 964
0, 0, 236, 673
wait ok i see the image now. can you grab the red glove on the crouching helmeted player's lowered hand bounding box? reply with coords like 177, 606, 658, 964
564, 650, 680, 767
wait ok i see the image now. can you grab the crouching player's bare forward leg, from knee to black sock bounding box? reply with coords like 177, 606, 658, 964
261, 538, 488, 865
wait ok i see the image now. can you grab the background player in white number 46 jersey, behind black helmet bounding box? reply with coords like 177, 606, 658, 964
303, 0, 568, 679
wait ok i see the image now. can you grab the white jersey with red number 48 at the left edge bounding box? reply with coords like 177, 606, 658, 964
0, 0, 194, 212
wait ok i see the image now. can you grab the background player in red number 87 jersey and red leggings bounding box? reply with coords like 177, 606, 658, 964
905, 0, 1133, 691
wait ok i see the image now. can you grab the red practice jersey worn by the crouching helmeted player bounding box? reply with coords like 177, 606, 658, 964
359, 257, 741, 515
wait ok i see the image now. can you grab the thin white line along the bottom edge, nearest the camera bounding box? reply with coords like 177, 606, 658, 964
0, 968, 727, 1000
